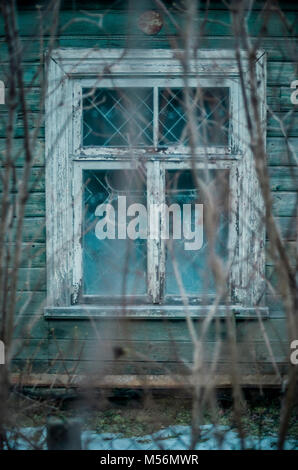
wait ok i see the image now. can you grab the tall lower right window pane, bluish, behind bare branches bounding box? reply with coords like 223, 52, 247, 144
166, 170, 229, 296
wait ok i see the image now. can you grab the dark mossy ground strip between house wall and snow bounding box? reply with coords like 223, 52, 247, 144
5, 391, 298, 442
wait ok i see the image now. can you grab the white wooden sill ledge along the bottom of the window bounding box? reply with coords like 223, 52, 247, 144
44, 305, 269, 320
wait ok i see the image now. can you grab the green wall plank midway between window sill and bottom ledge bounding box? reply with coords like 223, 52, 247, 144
12, 339, 291, 367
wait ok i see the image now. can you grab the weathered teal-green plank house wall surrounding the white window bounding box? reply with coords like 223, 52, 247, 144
0, 1, 298, 382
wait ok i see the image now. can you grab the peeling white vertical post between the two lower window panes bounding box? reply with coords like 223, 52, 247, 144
147, 161, 165, 303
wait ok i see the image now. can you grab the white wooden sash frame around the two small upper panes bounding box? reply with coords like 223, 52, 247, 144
72, 77, 242, 160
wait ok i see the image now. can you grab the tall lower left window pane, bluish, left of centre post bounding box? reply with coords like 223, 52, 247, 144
83, 170, 147, 296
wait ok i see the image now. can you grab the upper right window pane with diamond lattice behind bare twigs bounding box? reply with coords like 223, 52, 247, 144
159, 88, 229, 147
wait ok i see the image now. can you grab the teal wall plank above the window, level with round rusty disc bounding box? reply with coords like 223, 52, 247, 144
0, 9, 296, 39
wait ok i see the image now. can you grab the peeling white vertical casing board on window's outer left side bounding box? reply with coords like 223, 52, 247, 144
45, 58, 73, 305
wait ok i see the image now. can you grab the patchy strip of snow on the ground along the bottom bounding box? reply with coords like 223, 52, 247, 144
6, 424, 298, 450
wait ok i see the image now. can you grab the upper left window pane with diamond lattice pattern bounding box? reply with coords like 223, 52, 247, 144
83, 88, 153, 147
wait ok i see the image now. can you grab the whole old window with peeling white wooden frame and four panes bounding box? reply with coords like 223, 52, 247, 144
46, 50, 266, 316
